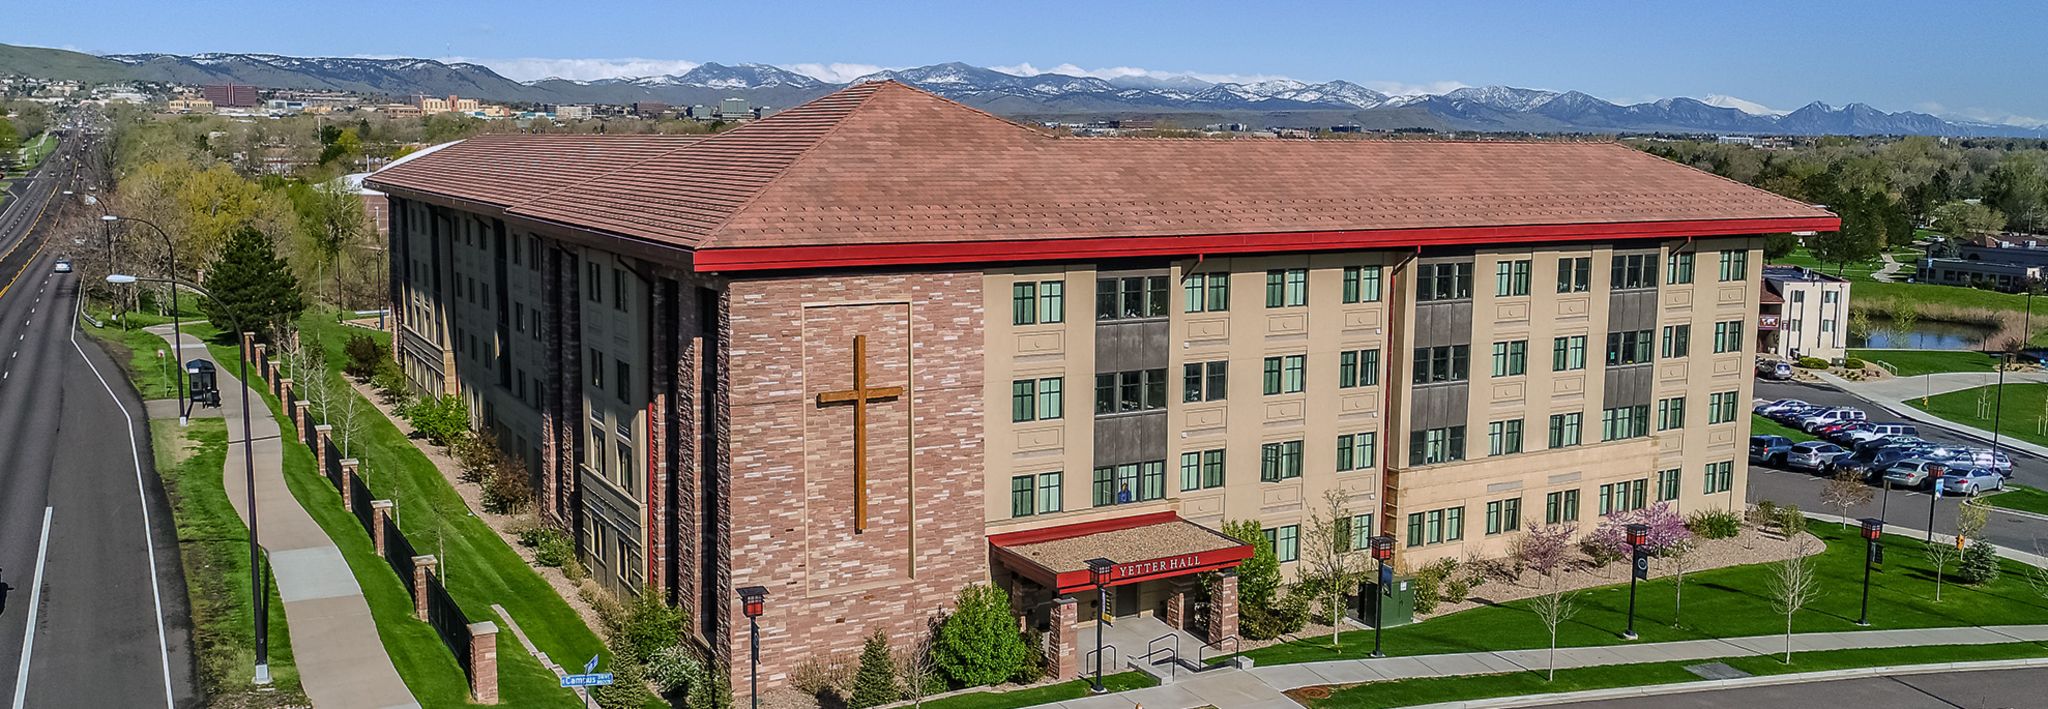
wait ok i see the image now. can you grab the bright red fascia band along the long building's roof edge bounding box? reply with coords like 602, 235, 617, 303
696, 217, 1841, 273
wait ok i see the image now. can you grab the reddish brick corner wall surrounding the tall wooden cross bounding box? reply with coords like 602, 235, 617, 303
725, 273, 987, 695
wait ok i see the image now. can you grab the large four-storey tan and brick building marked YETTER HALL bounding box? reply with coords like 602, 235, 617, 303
369, 82, 1837, 686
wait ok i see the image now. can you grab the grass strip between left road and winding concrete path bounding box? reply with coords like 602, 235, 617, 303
150, 418, 305, 707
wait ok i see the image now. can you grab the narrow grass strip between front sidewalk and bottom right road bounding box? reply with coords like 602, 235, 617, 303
1296, 643, 2048, 709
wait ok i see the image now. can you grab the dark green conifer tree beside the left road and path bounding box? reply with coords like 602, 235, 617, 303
201, 225, 305, 340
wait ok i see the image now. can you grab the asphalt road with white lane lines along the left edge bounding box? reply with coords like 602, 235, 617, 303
0, 135, 201, 709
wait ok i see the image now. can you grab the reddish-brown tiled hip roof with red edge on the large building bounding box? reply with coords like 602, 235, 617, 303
371, 82, 1839, 270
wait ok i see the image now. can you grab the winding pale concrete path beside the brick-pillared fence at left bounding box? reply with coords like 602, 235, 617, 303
147, 326, 420, 709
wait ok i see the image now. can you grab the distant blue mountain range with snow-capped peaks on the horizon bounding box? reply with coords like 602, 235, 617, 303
0, 45, 2048, 137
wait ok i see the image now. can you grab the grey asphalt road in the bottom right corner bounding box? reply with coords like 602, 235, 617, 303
1556, 670, 2048, 709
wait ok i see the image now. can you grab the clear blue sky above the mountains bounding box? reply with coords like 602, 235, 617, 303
16, 0, 2048, 119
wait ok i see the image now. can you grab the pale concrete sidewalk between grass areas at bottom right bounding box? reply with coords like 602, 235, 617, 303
1044, 625, 2048, 709
